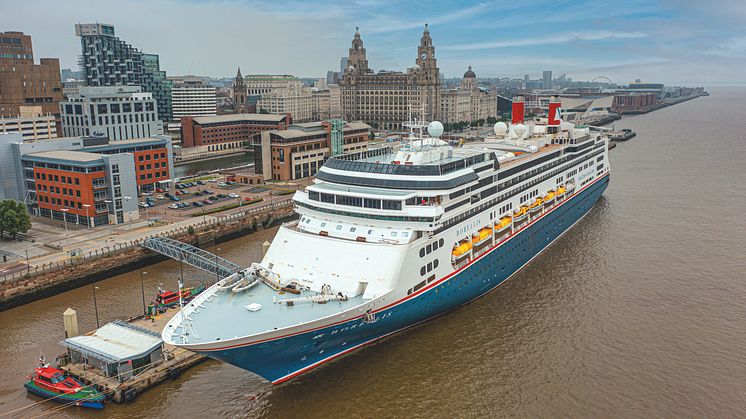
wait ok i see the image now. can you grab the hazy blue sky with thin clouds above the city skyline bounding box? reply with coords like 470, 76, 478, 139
0, 0, 746, 86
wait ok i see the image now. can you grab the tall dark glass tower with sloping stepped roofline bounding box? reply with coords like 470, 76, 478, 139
75, 23, 171, 121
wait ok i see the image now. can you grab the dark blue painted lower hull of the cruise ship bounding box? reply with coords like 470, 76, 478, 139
202, 175, 609, 384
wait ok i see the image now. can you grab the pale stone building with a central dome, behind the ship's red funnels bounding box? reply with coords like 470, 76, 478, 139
440, 66, 497, 124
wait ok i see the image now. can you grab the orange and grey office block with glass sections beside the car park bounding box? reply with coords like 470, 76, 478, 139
0, 133, 173, 226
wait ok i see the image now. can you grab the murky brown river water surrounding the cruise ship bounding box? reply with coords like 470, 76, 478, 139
0, 89, 746, 418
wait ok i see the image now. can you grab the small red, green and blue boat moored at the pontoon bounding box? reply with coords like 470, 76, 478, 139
23, 357, 106, 409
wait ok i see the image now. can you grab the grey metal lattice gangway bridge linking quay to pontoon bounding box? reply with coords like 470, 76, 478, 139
142, 237, 241, 278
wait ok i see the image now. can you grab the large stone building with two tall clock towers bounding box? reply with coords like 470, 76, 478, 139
339, 25, 441, 129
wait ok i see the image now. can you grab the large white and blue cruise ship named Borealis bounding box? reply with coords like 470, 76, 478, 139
163, 104, 610, 384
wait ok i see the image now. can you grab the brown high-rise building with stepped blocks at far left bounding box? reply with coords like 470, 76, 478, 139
0, 32, 62, 130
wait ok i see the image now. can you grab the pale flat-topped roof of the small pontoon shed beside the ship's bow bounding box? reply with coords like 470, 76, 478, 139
60, 320, 163, 362
